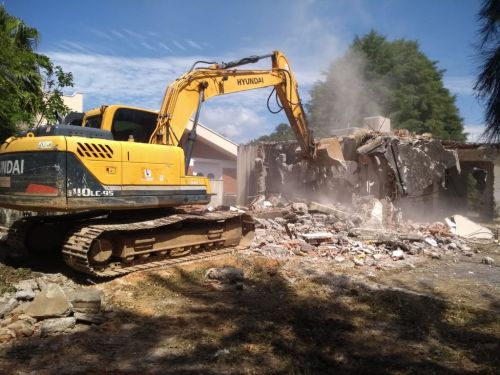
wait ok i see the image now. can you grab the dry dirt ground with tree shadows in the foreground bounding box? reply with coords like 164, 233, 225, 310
0, 245, 500, 374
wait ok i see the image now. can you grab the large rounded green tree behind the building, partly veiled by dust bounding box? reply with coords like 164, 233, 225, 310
308, 31, 465, 141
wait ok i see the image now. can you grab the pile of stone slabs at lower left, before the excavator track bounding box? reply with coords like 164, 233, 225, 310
0, 275, 104, 343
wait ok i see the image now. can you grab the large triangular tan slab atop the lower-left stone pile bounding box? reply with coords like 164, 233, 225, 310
25, 283, 71, 319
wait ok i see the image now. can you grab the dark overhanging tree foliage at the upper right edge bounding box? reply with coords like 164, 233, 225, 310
474, 0, 500, 143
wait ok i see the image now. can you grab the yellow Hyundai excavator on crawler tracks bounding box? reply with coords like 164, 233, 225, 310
0, 51, 322, 277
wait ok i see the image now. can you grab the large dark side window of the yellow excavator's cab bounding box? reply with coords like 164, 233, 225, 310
111, 108, 158, 143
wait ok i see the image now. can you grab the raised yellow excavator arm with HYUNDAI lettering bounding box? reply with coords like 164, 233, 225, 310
150, 51, 314, 158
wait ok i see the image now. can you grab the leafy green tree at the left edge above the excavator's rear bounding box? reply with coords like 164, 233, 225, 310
0, 5, 73, 141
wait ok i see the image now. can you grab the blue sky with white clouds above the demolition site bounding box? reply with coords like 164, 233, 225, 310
3, 0, 483, 142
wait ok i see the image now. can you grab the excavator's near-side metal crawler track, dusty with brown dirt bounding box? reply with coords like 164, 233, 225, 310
62, 212, 253, 278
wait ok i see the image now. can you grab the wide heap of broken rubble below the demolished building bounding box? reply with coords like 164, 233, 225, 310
246, 197, 493, 268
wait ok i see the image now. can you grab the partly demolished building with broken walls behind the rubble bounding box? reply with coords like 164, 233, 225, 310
238, 129, 500, 221
